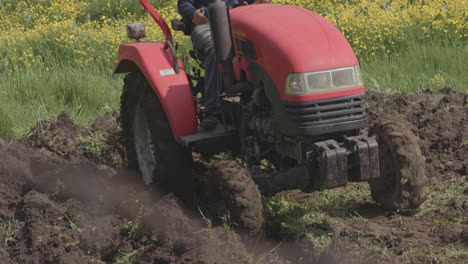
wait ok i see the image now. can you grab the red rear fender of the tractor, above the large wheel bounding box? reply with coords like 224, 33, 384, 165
114, 41, 197, 139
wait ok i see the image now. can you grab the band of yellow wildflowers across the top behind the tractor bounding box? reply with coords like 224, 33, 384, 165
0, 0, 468, 71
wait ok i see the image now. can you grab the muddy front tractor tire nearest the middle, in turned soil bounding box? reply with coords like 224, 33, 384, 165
209, 160, 264, 235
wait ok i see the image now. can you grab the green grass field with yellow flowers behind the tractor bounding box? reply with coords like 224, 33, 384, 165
0, 0, 468, 137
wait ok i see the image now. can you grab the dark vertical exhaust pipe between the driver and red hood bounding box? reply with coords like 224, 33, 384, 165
208, 0, 238, 94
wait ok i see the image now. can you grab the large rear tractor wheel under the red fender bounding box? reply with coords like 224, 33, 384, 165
120, 72, 193, 195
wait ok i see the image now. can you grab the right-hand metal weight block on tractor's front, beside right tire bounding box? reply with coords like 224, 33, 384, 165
345, 136, 380, 182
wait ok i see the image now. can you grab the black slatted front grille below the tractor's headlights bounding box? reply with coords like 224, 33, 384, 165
284, 94, 367, 135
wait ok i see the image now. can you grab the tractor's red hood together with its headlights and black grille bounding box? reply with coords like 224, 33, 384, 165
230, 5, 366, 137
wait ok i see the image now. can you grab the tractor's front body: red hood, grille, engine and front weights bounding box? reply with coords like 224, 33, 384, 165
225, 4, 379, 193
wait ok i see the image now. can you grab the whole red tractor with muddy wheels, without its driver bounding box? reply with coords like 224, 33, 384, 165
115, 0, 426, 231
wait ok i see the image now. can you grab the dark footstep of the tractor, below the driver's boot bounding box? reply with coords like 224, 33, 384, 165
177, 125, 240, 154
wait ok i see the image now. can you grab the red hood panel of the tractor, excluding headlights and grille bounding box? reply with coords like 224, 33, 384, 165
230, 4, 363, 101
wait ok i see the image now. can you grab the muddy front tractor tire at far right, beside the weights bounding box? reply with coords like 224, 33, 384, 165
369, 120, 427, 210
